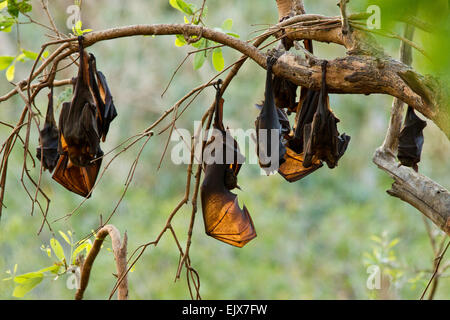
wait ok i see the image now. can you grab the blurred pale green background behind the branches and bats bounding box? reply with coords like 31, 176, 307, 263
0, 0, 450, 299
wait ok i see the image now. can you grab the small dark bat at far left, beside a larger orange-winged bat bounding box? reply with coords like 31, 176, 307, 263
36, 87, 59, 172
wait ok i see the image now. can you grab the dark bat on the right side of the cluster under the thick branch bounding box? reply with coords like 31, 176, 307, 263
303, 61, 350, 169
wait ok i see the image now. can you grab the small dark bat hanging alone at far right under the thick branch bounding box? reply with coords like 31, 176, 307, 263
397, 106, 427, 171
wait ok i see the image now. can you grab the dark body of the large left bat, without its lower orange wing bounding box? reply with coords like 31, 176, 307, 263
58, 37, 101, 167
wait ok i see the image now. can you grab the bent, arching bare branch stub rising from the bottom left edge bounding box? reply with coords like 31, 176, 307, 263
75, 224, 128, 300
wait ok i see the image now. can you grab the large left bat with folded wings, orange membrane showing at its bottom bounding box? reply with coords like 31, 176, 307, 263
53, 37, 117, 197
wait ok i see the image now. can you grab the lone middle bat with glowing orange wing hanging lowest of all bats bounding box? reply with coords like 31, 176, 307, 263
200, 80, 256, 248
